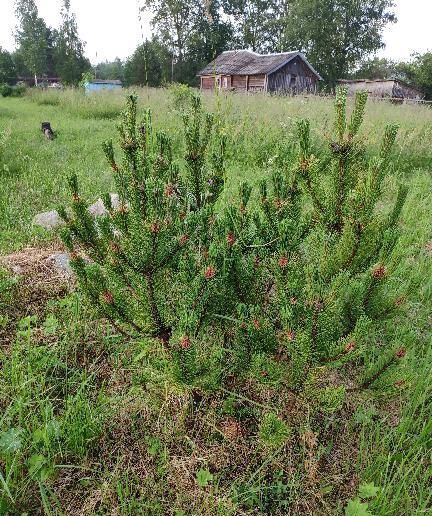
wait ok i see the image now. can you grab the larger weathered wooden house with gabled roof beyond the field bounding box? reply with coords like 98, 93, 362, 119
198, 50, 322, 94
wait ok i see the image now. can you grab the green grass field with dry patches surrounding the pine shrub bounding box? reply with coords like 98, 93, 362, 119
0, 89, 432, 516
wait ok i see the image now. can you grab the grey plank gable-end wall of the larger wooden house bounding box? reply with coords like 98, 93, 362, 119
267, 58, 318, 93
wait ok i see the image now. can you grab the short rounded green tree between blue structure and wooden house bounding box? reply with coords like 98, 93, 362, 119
124, 39, 171, 86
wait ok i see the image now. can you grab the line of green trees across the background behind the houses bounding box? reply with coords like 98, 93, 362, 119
0, 0, 432, 97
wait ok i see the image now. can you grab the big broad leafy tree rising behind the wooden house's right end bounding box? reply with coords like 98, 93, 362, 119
284, 0, 396, 87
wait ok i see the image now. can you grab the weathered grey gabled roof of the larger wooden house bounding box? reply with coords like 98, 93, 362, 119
198, 50, 321, 79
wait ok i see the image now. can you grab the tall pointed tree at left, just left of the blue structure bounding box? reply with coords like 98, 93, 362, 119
55, 0, 90, 85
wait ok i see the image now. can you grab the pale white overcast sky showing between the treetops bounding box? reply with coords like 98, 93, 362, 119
0, 0, 432, 63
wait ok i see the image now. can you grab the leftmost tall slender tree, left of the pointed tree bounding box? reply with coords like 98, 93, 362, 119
15, 0, 48, 81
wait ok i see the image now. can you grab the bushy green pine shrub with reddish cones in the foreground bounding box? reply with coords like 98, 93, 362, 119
60, 89, 407, 396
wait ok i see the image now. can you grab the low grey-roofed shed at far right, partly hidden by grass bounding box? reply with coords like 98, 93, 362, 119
338, 79, 424, 100
